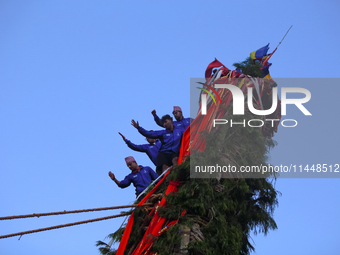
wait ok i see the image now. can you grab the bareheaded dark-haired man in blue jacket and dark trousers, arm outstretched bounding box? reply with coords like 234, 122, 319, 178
131, 114, 184, 172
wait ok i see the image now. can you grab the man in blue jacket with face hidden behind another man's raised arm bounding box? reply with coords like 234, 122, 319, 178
118, 132, 162, 174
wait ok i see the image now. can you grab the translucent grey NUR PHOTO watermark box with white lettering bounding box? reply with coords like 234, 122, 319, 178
190, 77, 340, 178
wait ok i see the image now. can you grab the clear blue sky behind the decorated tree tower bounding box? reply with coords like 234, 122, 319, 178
0, 0, 340, 255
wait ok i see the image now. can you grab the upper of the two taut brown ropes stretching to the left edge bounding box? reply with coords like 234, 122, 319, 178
0, 203, 152, 220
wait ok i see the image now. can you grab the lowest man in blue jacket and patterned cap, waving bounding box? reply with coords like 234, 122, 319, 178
109, 156, 158, 200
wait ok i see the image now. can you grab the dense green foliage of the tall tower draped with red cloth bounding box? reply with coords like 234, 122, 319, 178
97, 54, 280, 255
